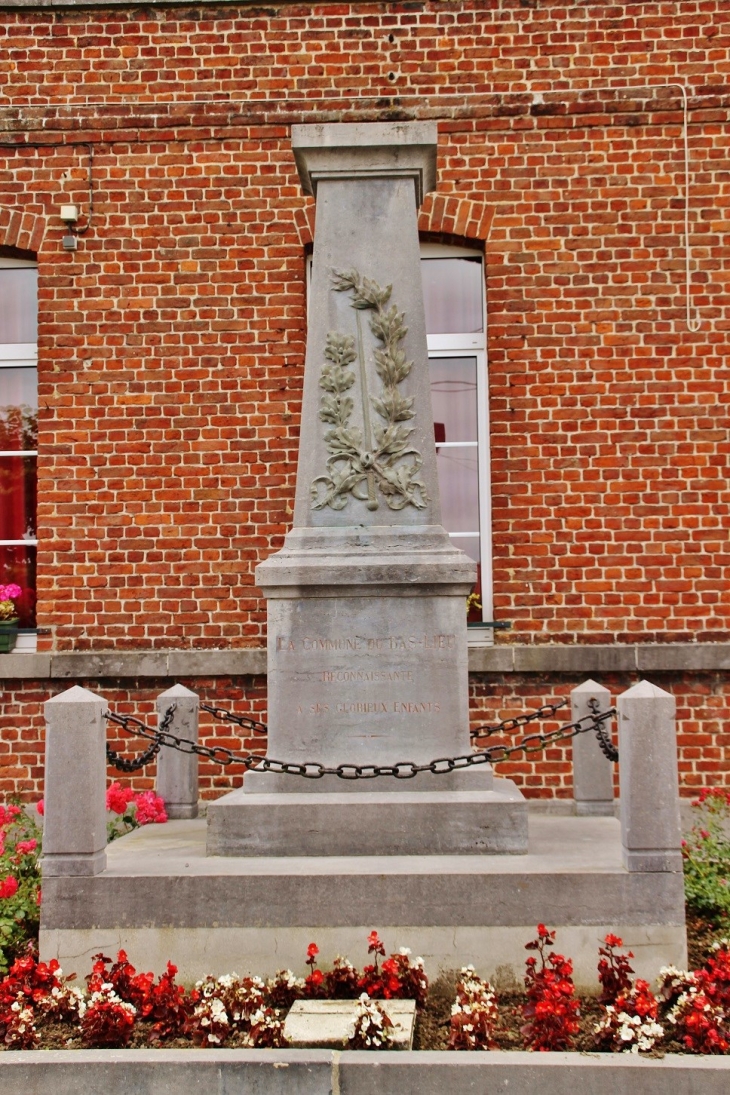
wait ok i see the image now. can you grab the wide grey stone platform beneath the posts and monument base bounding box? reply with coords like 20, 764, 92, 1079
40, 815, 686, 988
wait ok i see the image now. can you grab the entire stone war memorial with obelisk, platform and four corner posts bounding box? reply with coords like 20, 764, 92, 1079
40, 123, 686, 983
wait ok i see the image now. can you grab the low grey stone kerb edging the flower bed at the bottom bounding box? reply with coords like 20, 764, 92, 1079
0, 1049, 730, 1095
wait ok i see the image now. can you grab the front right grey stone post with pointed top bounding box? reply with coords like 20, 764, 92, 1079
618, 681, 682, 872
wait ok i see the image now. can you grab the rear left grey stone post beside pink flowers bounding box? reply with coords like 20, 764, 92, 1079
157, 684, 200, 818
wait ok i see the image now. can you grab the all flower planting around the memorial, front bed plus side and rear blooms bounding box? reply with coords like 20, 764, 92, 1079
0, 783, 730, 1054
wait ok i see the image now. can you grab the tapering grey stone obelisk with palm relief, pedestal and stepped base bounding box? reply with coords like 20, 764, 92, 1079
209, 123, 526, 855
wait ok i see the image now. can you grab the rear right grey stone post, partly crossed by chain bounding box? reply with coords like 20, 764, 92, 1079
570, 681, 614, 817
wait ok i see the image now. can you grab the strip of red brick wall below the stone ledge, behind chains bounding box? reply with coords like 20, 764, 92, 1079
0, 673, 730, 802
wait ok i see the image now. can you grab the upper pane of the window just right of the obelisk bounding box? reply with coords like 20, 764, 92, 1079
420, 258, 484, 335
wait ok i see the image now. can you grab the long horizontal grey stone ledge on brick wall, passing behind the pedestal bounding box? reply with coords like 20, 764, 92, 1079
0, 643, 730, 681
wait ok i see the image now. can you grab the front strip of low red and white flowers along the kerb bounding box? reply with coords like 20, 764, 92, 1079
0, 924, 730, 1054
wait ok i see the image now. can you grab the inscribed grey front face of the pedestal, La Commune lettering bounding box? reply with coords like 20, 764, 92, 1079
269, 598, 468, 763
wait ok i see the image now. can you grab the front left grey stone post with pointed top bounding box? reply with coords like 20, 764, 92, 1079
40, 685, 107, 877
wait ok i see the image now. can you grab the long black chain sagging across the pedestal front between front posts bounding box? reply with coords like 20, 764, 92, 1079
102, 707, 616, 780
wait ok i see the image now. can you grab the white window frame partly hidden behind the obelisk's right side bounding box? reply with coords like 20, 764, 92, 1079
420, 243, 494, 646
